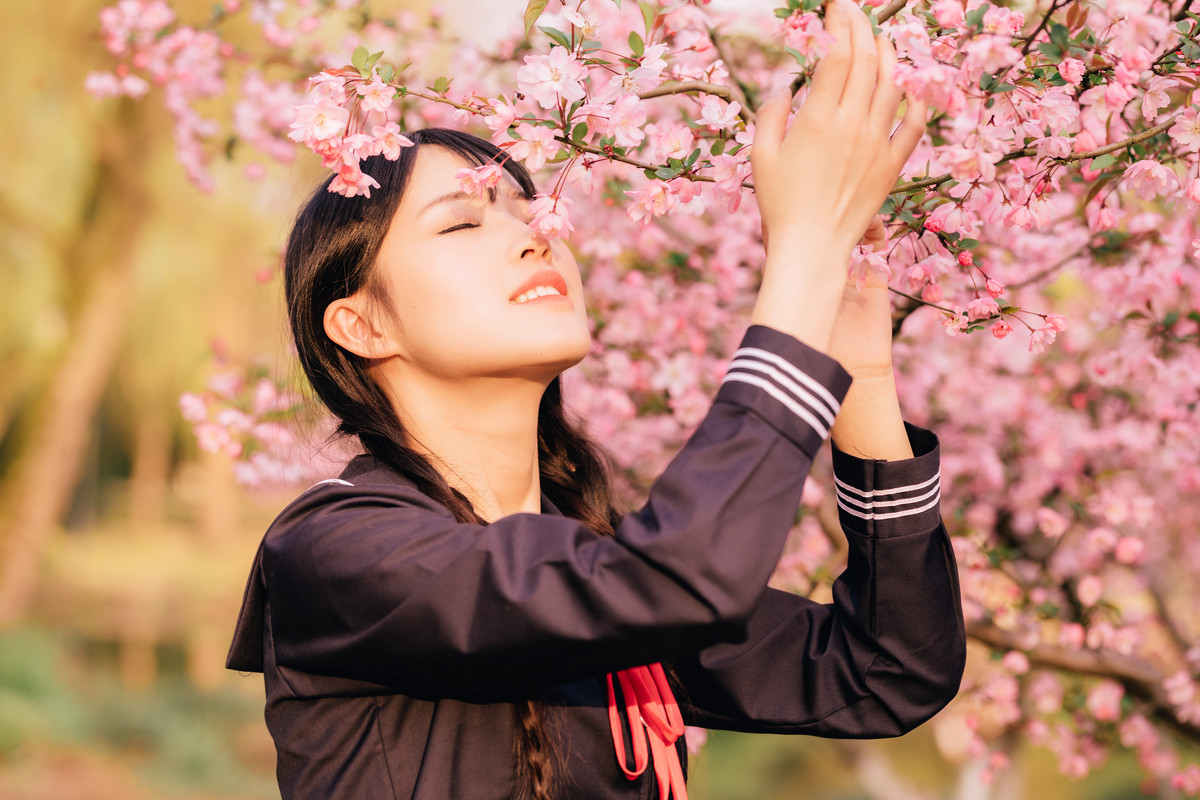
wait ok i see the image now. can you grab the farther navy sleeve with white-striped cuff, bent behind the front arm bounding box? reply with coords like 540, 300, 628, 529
676, 423, 966, 738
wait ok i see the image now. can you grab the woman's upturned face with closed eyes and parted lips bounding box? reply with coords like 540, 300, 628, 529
376, 145, 590, 383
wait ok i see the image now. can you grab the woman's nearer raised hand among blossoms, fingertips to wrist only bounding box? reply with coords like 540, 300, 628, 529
750, 0, 925, 266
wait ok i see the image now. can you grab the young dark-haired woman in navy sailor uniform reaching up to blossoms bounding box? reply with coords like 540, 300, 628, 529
228, 0, 965, 800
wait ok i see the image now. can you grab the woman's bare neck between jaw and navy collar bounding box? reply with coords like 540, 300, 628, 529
379, 374, 547, 522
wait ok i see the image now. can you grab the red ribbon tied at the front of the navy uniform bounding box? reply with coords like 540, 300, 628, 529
608, 663, 688, 800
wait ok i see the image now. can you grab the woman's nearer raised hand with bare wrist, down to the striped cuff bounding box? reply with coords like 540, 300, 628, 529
750, 0, 925, 350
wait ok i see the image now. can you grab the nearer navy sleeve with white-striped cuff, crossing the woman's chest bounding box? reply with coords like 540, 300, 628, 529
262, 325, 850, 692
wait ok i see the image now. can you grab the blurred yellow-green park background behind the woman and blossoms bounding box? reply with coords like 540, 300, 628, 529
0, 0, 1180, 800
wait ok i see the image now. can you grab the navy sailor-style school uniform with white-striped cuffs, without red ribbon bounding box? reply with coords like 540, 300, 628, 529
227, 325, 965, 800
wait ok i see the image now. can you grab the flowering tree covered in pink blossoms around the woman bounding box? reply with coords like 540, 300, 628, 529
88, 0, 1200, 796
